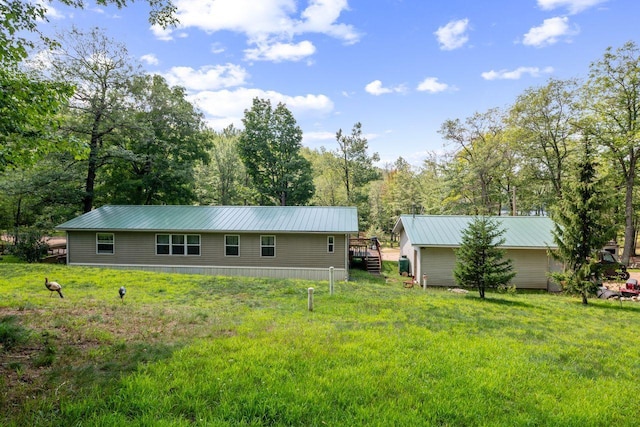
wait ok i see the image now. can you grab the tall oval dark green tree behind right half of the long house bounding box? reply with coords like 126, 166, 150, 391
238, 98, 314, 206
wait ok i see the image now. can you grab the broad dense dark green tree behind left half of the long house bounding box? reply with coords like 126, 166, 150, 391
103, 75, 209, 205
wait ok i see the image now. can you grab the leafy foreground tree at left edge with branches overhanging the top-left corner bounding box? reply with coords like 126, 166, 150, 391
0, 0, 176, 171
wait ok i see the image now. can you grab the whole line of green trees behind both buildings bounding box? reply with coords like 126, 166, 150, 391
0, 17, 640, 262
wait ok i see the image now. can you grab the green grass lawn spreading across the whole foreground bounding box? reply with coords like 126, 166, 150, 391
0, 264, 640, 426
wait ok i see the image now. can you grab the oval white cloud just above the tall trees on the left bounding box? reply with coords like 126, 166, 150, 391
163, 64, 249, 91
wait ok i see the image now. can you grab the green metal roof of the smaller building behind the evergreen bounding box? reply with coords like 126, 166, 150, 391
394, 215, 556, 248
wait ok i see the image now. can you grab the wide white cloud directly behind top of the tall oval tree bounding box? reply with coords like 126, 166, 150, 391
189, 88, 333, 129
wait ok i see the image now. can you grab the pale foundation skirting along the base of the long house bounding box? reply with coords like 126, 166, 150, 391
68, 263, 349, 281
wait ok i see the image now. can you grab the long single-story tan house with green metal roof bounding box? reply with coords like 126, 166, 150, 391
56, 206, 358, 280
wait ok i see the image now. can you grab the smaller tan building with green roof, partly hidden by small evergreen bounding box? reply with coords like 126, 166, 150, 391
393, 215, 562, 291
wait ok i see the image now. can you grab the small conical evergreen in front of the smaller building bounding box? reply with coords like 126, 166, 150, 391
453, 217, 516, 298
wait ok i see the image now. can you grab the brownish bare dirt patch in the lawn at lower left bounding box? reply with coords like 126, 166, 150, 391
0, 304, 220, 420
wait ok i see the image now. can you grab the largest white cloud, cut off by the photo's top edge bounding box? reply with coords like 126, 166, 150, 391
151, 0, 361, 61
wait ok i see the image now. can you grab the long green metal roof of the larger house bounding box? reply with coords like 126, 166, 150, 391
56, 206, 358, 233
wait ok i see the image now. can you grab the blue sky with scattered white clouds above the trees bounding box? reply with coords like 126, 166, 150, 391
38, 0, 640, 166
